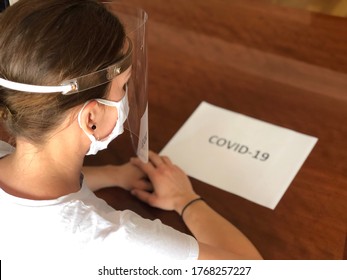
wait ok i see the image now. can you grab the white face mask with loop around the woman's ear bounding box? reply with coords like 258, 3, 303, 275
78, 87, 129, 155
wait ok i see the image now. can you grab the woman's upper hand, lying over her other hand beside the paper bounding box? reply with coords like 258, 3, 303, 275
130, 151, 199, 214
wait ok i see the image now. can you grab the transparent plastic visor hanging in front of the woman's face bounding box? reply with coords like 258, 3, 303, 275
103, 1, 148, 162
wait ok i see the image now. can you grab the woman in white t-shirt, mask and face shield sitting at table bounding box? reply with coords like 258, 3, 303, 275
0, 0, 261, 259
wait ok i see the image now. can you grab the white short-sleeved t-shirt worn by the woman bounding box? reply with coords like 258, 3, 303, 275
0, 141, 198, 260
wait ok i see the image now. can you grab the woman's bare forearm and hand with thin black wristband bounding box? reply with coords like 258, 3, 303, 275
131, 152, 262, 259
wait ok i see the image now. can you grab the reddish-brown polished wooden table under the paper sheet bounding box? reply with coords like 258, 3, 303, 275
3, 0, 347, 259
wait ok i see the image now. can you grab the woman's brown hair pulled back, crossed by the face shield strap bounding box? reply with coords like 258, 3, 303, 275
0, 0, 125, 144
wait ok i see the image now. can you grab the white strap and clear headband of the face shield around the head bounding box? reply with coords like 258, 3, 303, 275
0, 37, 133, 95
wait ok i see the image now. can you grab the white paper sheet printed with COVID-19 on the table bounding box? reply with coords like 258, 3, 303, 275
160, 102, 318, 209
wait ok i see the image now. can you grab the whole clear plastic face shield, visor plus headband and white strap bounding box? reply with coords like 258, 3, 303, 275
0, 1, 148, 162
